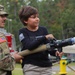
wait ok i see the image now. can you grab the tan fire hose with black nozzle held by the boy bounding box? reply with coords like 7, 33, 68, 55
19, 37, 75, 56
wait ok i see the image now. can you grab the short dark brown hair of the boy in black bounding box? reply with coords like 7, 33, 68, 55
19, 6, 38, 26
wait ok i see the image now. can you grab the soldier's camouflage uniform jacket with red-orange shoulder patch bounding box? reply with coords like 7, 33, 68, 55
0, 32, 15, 75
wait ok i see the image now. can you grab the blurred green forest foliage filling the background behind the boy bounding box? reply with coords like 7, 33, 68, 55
0, 0, 75, 45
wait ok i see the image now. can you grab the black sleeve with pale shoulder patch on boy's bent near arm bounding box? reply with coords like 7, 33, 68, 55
19, 28, 46, 50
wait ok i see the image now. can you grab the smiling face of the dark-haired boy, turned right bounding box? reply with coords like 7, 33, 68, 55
24, 14, 40, 28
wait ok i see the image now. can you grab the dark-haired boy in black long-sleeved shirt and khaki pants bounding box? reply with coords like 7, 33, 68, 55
19, 6, 62, 75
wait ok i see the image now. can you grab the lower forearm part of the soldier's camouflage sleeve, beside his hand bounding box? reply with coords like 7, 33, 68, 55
0, 55, 15, 70
